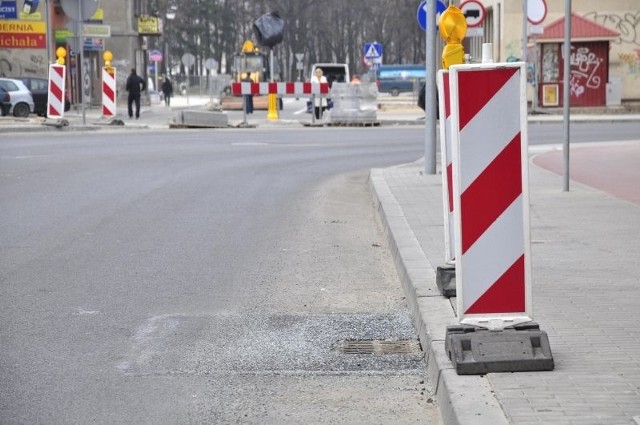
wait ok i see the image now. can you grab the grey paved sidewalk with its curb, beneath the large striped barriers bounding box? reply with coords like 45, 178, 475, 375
370, 140, 640, 425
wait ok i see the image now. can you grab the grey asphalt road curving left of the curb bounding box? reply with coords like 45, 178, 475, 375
0, 128, 439, 424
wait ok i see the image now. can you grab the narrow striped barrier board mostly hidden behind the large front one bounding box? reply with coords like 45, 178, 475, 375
438, 69, 456, 264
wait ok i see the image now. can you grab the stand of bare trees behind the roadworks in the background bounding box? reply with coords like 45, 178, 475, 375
168, 0, 425, 79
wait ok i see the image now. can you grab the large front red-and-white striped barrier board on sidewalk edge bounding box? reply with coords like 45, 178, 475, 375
449, 62, 532, 329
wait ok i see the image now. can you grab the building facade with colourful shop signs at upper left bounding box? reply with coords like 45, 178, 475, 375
0, 0, 154, 104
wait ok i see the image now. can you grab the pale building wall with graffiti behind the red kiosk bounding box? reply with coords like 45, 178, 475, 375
465, 0, 640, 106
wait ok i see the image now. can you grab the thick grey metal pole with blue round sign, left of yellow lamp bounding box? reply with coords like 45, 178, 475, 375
424, 0, 437, 174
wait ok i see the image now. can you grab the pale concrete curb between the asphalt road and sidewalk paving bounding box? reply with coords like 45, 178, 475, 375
369, 167, 509, 425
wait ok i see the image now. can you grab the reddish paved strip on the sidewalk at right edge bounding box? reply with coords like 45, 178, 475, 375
533, 142, 640, 205
